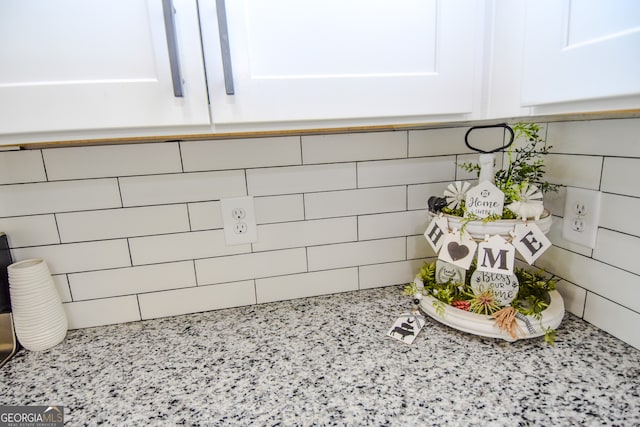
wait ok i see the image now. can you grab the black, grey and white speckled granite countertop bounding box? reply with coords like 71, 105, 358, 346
0, 286, 640, 426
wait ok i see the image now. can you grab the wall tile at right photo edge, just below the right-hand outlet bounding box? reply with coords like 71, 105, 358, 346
593, 228, 640, 274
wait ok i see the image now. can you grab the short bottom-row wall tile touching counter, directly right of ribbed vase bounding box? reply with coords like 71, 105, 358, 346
62, 295, 141, 329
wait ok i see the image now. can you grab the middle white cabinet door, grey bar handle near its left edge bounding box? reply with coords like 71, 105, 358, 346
200, 0, 484, 125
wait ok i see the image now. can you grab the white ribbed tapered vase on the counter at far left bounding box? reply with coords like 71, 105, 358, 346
7, 259, 68, 351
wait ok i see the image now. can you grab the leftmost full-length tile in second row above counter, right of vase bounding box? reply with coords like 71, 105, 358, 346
69, 261, 196, 301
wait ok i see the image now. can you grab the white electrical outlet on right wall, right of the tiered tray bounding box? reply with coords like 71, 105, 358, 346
562, 187, 602, 249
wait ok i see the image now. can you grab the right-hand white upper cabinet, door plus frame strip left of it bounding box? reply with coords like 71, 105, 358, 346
490, 0, 640, 117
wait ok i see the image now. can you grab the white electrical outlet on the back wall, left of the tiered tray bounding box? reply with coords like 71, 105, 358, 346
220, 196, 258, 245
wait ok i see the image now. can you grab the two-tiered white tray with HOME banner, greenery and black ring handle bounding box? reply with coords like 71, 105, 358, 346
405, 123, 564, 344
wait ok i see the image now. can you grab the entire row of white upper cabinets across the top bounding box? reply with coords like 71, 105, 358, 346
0, 0, 640, 145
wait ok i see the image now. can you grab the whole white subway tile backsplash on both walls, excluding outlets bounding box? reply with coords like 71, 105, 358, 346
0, 118, 640, 352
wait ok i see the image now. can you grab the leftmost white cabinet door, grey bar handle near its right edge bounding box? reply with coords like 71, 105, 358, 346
0, 0, 210, 141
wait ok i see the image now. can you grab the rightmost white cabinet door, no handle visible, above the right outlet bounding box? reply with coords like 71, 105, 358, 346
521, 0, 640, 106
